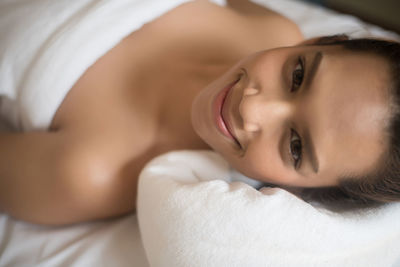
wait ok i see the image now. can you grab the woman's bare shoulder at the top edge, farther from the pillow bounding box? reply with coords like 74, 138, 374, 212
148, 0, 303, 55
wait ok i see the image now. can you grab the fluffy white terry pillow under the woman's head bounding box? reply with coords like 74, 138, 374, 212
137, 151, 400, 267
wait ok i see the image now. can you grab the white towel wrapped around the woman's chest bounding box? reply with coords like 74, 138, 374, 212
0, 0, 195, 130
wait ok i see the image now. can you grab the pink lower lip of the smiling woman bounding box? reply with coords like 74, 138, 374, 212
213, 81, 238, 142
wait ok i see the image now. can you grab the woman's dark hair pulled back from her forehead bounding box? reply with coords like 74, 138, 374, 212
300, 35, 400, 211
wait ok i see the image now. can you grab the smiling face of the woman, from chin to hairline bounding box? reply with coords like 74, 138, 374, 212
192, 46, 390, 187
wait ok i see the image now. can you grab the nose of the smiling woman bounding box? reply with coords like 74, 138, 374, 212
239, 87, 293, 132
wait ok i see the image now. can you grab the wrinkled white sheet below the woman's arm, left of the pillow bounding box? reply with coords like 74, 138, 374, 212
0, 214, 148, 267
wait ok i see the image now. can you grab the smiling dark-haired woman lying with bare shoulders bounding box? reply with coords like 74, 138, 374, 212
0, 0, 400, 224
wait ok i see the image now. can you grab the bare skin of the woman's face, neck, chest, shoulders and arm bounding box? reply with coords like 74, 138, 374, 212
0, 0, 387, 225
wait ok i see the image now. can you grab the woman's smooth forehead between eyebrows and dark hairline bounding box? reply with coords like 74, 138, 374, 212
305, 49, 390, 177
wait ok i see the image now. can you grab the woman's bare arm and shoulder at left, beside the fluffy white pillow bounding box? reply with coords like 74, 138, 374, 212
0, 131, 137, 225
